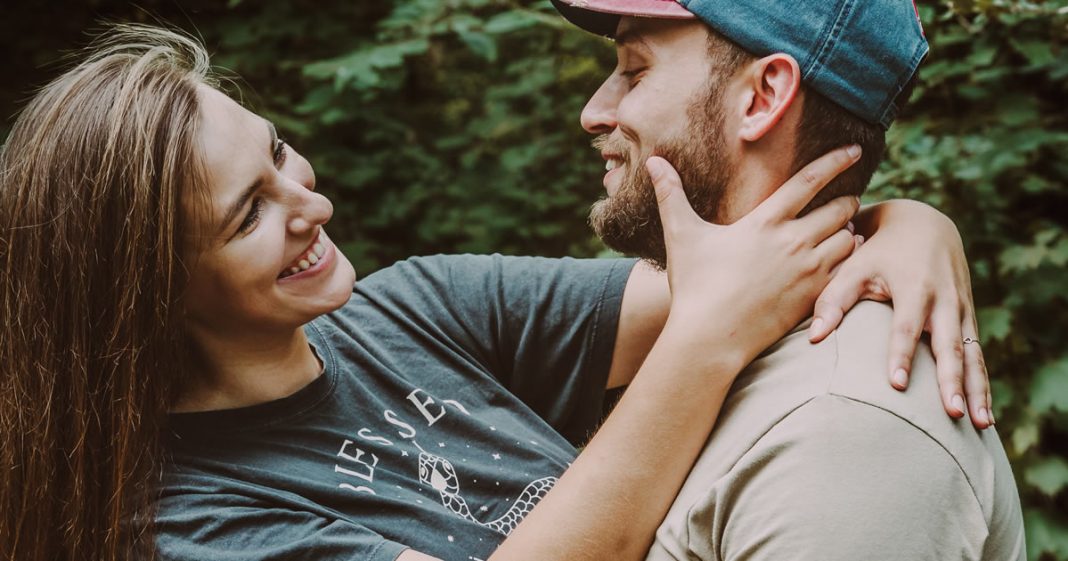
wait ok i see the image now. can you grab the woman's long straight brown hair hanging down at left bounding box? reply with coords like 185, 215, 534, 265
0, 26, 215, 561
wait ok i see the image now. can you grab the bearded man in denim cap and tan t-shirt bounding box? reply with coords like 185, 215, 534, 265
554, 0, 1024, 560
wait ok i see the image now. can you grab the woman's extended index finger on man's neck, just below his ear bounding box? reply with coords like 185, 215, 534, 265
750, 144, 861, 222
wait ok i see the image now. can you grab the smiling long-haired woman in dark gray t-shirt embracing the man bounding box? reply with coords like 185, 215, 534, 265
0, 27, 988, 561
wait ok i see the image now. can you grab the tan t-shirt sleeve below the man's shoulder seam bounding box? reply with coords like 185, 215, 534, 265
687, 395, 988, 561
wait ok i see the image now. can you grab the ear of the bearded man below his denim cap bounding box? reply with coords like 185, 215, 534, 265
738, 52, 801, 142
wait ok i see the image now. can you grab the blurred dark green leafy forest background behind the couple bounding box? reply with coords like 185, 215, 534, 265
0, 0, 1068, 560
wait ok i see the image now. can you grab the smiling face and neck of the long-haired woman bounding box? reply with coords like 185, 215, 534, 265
175, 87, 356, 411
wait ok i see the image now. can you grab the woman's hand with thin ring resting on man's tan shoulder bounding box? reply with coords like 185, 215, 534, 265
810, 200, 994, 428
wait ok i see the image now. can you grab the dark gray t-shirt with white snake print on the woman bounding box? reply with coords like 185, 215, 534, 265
151, 255, 633, 561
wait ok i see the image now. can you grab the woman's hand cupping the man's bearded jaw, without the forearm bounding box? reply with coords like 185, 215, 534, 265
646, 146, 860, 364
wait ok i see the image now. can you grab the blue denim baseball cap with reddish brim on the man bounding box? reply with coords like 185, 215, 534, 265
552, 0, 928, 128
